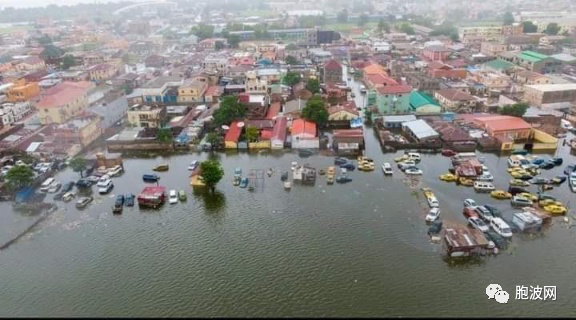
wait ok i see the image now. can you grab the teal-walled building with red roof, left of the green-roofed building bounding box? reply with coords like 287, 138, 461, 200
376, 84, 412, 115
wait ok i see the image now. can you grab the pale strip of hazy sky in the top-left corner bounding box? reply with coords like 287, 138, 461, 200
0, 1, 134, 23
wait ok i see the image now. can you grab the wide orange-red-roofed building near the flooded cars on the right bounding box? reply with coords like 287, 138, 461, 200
472, 115, 532, 141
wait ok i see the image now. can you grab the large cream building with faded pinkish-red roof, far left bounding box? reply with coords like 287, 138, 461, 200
36, 81, 93, 124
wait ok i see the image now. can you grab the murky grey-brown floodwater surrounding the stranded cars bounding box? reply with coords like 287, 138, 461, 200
0, 69, 576, 317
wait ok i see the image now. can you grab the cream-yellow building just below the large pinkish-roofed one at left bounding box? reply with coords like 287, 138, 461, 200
52, 114, 102, 148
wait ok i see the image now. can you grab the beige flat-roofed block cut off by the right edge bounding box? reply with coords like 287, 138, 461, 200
524, 83, 576, 106
